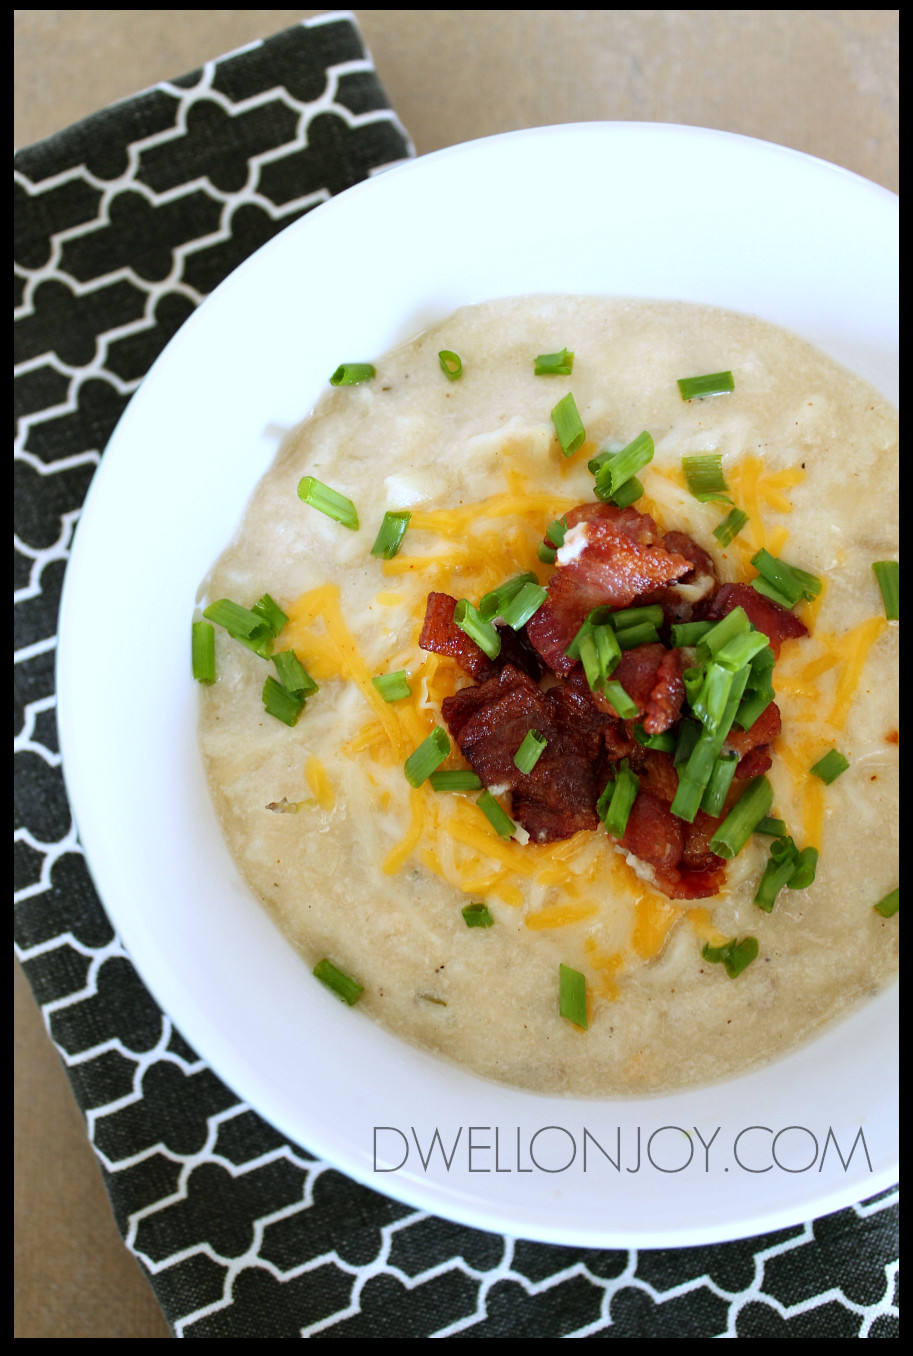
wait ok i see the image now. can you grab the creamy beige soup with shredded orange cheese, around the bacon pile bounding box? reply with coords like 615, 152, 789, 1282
199, 297, 898, 1096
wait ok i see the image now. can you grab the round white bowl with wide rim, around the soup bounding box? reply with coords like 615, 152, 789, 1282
58, 123, 898, 1248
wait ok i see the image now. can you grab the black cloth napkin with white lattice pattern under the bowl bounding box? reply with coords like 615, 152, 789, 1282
15, 14, 897, 1337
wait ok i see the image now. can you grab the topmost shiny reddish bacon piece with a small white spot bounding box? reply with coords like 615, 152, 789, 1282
526, 504, 693, 674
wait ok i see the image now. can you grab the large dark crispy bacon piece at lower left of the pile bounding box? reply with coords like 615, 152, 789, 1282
441, 664, 602, 842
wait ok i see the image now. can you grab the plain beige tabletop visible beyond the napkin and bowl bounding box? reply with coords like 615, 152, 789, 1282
14, 9, 898, 1337
